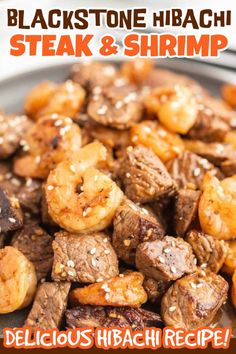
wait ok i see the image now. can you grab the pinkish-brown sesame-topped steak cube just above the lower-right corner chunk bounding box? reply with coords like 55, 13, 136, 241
135, 236, 196, 281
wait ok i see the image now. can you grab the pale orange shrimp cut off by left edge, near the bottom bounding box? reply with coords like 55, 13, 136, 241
0, 246, 37, 313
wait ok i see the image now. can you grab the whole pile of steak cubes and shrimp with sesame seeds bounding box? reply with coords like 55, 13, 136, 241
0, 59, 236, 330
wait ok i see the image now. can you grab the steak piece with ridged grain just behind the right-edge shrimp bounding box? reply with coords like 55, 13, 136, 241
168, 151, 221, 189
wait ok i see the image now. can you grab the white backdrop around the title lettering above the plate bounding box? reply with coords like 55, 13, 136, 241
0, 0, 236, 80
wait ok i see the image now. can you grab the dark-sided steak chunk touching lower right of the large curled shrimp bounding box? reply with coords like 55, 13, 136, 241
112, 199, 165, 264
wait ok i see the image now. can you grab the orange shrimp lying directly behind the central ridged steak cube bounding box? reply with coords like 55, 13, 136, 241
131, 120, 184, 162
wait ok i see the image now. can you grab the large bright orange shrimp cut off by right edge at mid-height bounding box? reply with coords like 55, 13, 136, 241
199, 173, 236, 240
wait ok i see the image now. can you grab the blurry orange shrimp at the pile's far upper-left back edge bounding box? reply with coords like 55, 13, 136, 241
24, 81, 57, 119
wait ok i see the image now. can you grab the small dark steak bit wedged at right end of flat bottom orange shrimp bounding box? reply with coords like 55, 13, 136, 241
143, 278, 171, 304
